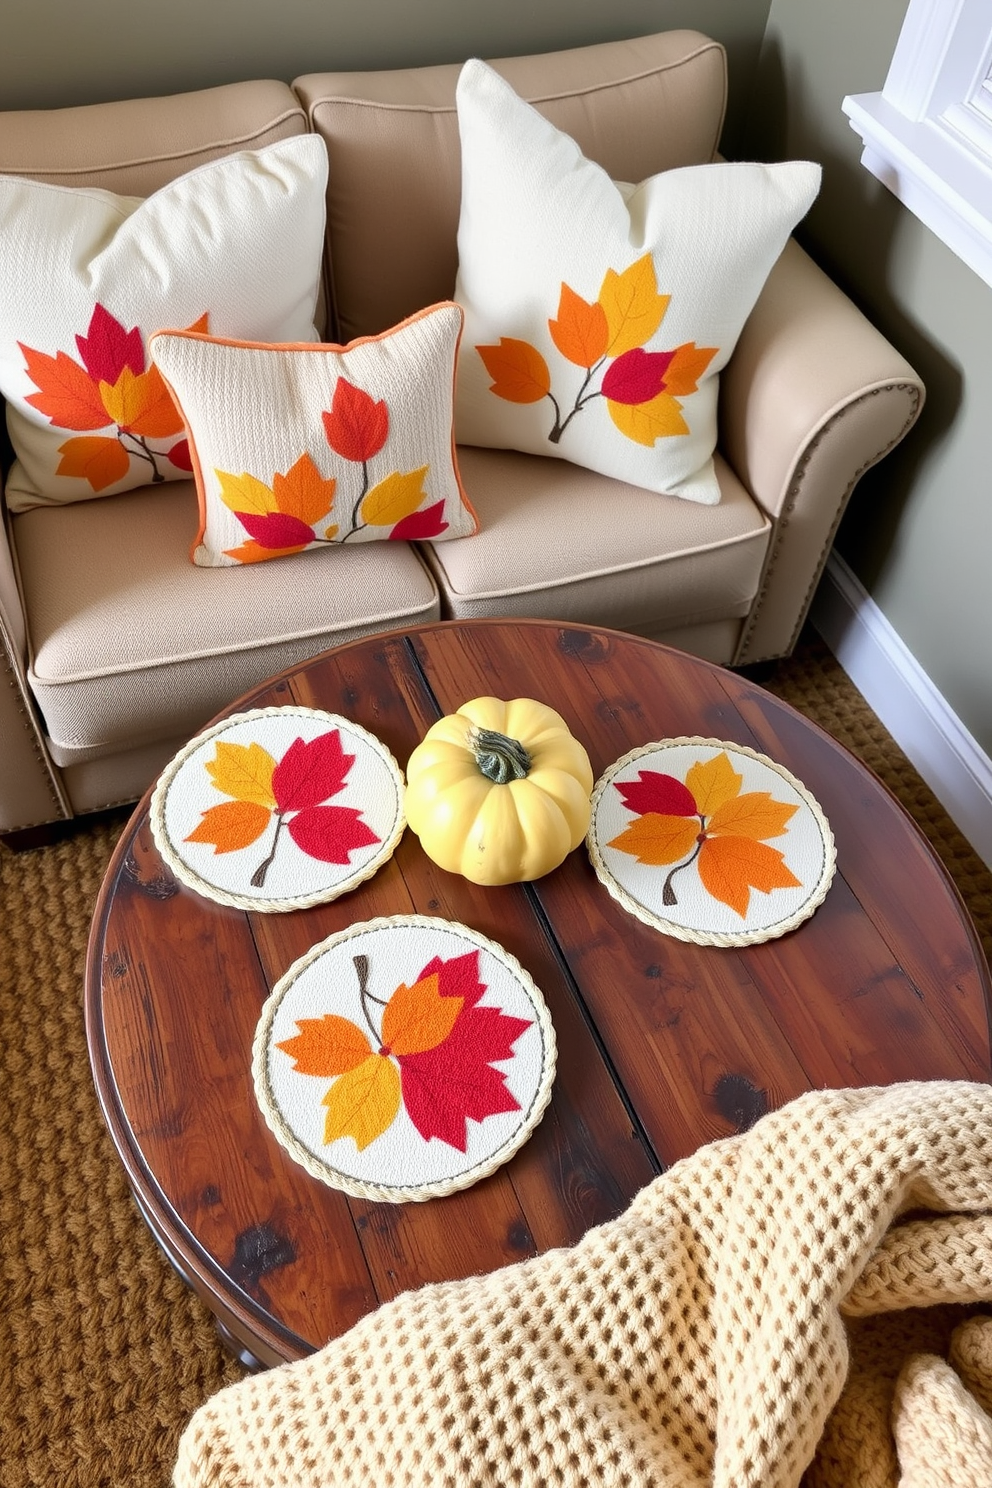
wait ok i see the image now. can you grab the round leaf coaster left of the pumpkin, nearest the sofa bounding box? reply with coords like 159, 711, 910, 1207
152, 705, 406, 911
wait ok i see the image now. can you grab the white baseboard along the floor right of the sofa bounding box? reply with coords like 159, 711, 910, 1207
809, 552, 992, 868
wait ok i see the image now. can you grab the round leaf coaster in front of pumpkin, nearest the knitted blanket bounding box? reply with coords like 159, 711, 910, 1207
251, 915, 556, 1204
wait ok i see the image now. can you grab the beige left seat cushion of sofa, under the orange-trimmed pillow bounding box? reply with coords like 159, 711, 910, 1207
12, 481, 439, 763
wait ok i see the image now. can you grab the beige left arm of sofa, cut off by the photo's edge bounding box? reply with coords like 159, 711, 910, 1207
0, 522, 73, 835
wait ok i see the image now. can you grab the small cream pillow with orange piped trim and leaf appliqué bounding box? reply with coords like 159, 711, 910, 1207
149, 301, 479, 568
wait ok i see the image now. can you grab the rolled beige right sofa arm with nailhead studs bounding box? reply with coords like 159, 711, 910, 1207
720, 240, 924, 665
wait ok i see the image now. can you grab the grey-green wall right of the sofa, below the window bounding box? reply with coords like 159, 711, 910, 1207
745, 0, 992, 754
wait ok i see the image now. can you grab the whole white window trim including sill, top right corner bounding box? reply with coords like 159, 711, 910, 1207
842, 0, 992, 286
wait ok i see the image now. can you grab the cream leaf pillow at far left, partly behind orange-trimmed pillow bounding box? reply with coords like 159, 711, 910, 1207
0, 135, 327, 512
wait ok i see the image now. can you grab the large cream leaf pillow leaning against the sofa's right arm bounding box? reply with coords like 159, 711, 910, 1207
455, 61, 821, 504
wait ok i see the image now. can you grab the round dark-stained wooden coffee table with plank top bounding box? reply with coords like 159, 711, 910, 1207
86, 620, 992, 1364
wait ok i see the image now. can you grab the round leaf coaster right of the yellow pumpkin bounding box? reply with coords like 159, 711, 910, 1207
586, 738, 836, 946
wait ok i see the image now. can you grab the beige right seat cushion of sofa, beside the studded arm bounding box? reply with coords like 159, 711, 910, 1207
425, 445, 772, 635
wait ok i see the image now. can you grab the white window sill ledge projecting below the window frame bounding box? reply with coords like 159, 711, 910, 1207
843, 92, 992, 286
